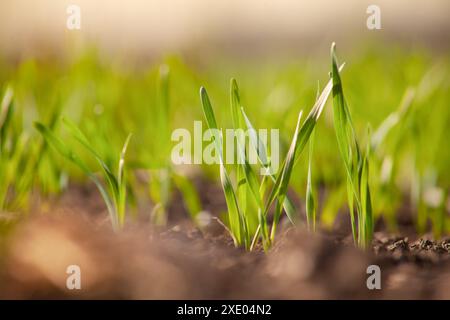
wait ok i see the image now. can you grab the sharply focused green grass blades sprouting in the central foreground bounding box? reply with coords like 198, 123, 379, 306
200, 44, 373, 250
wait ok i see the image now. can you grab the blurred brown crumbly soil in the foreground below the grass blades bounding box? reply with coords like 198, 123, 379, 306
0, 185, 450, 299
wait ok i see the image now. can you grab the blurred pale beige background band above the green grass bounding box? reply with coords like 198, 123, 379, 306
0, 0, 450, 58
